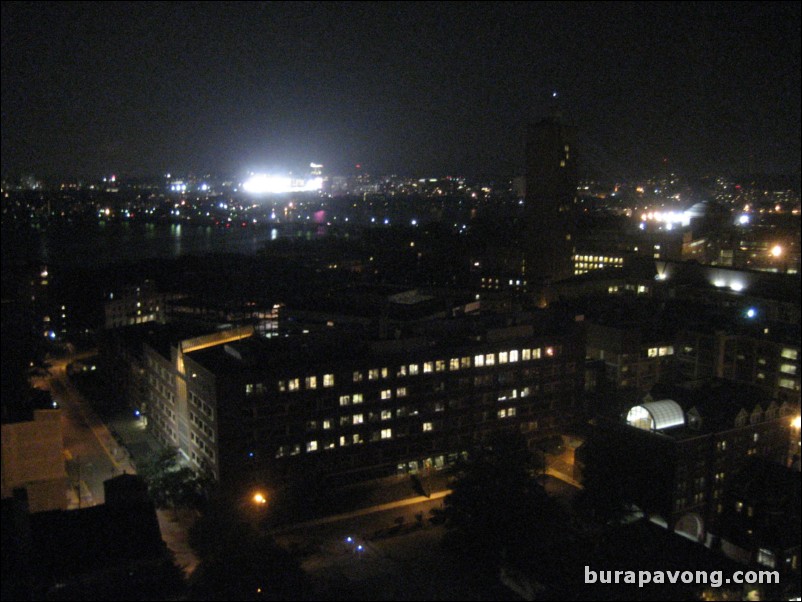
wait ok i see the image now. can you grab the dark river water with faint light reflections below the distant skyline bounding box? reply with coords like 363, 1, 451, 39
2, 224, 284, 267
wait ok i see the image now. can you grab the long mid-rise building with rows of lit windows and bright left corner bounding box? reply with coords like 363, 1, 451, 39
123, 316, 584, 481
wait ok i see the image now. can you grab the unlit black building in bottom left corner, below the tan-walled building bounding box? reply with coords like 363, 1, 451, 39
2, 475, 182, 600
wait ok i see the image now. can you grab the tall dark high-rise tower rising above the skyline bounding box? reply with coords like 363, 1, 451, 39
523, 111, 577, 282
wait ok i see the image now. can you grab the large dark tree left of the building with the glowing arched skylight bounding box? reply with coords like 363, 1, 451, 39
444, 433, 568, 570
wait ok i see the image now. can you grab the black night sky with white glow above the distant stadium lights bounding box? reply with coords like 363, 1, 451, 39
2, 2, 801, 178
